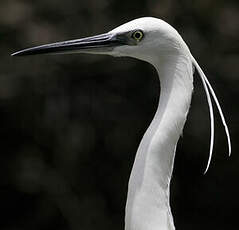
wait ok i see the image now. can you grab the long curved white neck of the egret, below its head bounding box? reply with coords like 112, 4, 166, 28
125, 55, 193, 230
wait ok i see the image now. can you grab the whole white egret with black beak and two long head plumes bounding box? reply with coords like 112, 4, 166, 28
12, 17, 231, 230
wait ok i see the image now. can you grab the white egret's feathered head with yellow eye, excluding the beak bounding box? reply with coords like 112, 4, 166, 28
109, 17, 188, 63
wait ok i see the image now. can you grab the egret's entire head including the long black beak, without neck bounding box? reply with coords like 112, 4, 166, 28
12, 17, 187, 63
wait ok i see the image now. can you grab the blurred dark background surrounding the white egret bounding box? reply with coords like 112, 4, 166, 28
0, 0, 239, 230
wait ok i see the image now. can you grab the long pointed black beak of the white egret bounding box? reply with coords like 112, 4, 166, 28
12, 33, 126, 56
